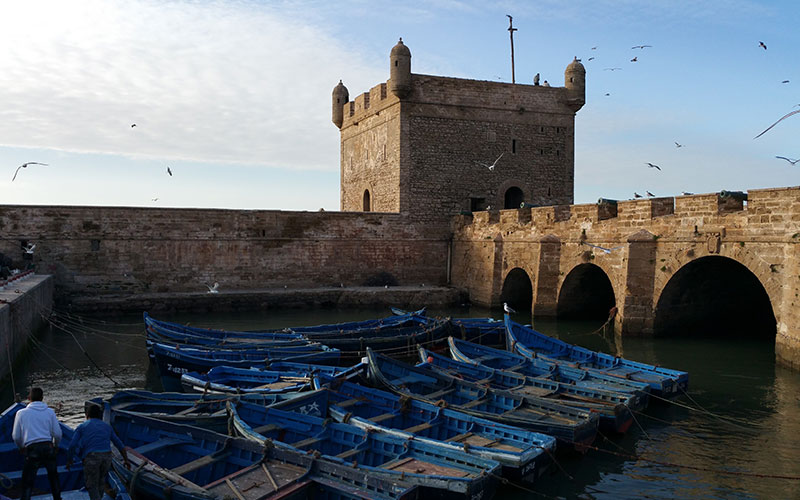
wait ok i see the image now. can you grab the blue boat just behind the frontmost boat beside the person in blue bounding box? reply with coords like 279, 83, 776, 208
229, 403, 500, 500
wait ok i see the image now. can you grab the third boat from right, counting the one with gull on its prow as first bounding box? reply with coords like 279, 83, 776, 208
417, 347, 644, 433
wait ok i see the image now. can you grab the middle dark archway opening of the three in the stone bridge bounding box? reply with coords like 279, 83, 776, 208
556, 264, 616, 319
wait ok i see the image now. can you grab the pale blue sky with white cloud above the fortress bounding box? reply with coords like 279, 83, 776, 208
0, 0, 800, 211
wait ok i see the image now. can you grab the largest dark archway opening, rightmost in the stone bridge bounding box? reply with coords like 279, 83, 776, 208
653, 256, 776, 338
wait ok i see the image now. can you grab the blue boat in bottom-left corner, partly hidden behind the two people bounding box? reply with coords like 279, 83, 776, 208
0, 403, 130, 500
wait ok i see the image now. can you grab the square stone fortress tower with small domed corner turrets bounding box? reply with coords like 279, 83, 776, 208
332, 38, 586, 224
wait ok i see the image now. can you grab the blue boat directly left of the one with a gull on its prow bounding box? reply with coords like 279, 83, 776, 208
448, 337, 650, 398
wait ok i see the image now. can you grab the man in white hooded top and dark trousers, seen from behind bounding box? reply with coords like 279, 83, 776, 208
11, 387, 61, 500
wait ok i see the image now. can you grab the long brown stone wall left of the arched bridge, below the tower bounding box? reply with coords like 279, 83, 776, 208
0, 206, 448, 304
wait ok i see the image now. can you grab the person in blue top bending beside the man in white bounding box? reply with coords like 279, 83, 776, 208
67, 404, 130, 500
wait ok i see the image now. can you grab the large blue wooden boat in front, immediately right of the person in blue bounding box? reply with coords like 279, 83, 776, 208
106, 408, 416, 500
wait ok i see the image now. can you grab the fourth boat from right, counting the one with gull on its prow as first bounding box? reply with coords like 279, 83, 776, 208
367, 350, 598, 451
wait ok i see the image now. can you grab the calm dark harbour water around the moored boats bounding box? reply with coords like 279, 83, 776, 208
0, 308, 800, 500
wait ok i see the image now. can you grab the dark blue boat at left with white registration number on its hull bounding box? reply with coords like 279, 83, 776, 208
153, 343, 339, 390
